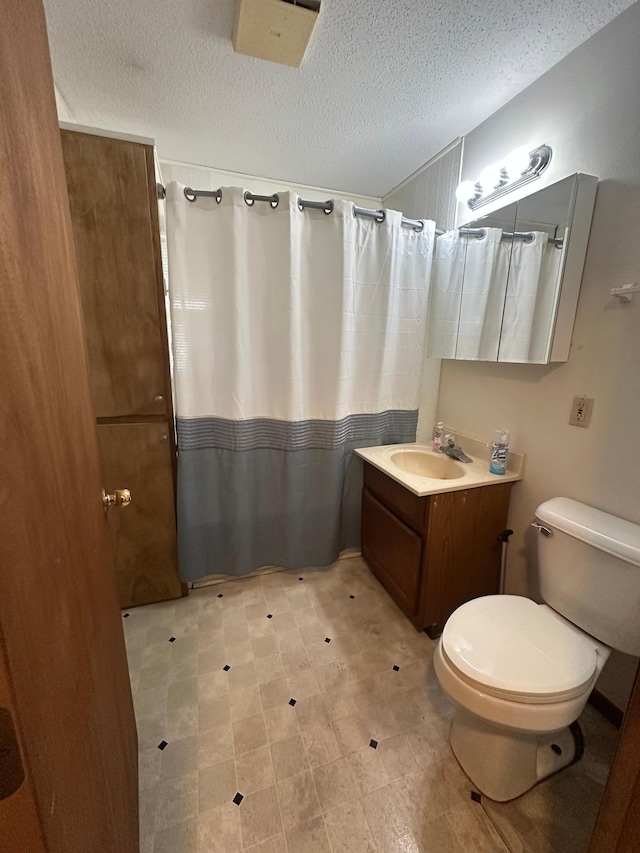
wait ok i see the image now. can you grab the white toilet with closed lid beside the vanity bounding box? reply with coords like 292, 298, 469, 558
434, 498, 640, 802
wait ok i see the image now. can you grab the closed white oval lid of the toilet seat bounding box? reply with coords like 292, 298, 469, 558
442, 595, 597, 698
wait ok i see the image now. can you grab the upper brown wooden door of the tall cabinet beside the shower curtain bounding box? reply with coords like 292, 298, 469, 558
62, 131, 168, 418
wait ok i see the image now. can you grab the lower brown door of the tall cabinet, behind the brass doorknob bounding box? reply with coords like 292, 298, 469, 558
98, 422, 182, 607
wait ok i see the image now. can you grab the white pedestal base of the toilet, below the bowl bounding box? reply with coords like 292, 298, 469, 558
449, 708, 583, 803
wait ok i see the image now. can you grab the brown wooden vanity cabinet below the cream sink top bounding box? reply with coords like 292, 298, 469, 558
362, 462, 512, 636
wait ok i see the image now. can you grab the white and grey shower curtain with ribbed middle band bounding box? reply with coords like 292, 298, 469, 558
167, 183, 434, 580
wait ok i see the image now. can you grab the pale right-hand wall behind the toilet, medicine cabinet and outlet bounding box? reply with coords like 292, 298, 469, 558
438, 3, 640, 707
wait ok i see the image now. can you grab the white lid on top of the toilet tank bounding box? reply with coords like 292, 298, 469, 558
536, 498, 640, 566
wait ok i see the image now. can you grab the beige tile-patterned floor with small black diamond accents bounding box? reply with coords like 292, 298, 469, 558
123, 558, 607, 853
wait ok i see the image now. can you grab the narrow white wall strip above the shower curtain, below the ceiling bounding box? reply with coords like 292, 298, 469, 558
160, 159, 382, 209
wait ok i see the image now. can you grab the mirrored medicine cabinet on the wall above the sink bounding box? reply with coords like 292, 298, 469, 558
427, 173, 598, 364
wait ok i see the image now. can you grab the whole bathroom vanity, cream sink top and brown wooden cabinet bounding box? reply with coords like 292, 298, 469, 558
356, 439, 523, 637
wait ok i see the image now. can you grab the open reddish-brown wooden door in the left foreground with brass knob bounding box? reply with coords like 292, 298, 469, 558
0, 0, 138, 853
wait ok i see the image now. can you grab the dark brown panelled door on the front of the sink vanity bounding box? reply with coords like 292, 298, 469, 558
362, 489, 422, 617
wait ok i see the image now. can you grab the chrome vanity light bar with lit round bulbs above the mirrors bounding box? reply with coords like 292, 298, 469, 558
456, 145, 552, 210
